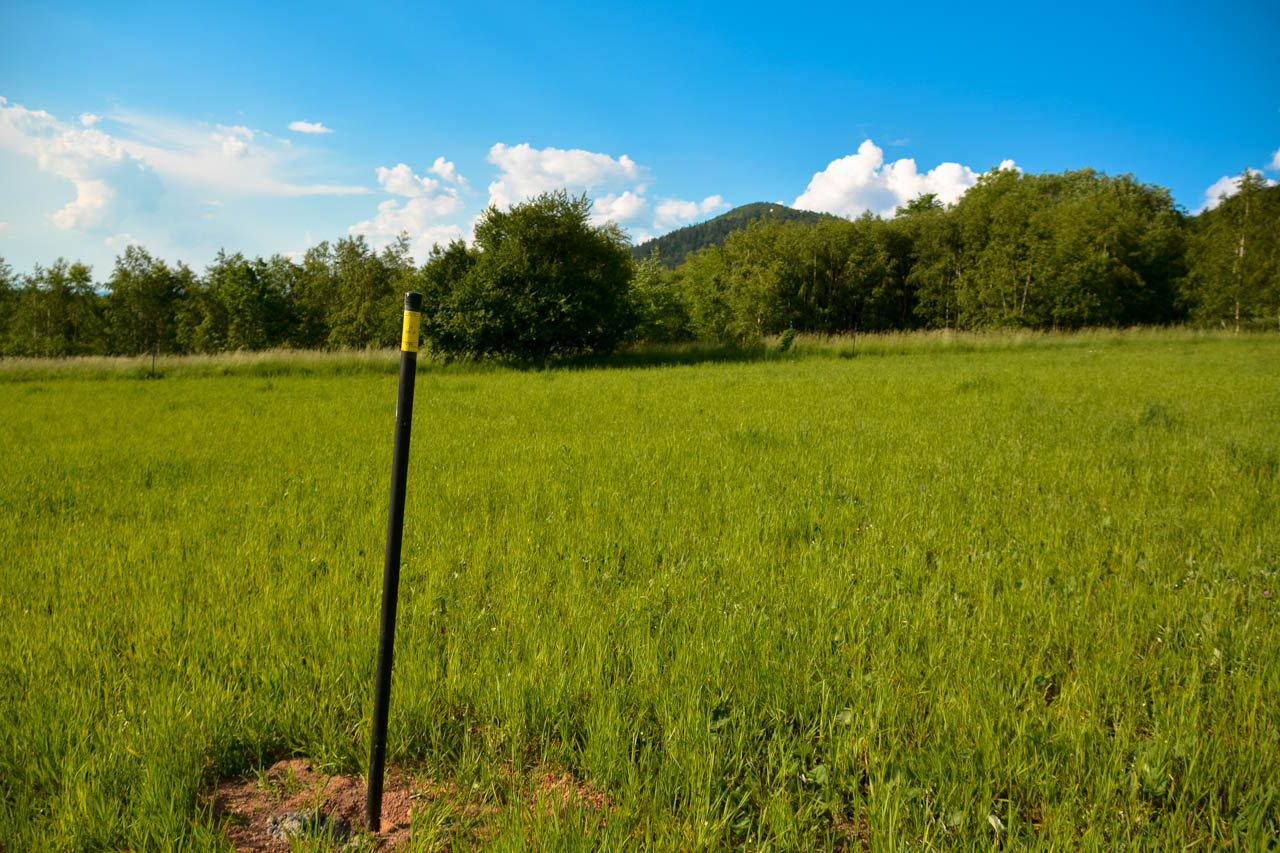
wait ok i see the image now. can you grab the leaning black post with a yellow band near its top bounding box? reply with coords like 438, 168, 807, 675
365, 292, 422, 833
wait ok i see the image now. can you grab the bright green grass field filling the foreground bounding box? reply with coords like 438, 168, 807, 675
0, 332, 1280, 850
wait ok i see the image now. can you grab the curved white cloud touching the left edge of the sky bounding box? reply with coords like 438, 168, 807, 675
0, 99, 161, 231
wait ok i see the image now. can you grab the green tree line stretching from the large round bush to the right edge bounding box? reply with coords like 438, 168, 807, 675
636, 163, 1280, 339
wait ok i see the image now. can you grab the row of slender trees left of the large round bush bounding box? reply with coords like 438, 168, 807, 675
0, 237, 417, 357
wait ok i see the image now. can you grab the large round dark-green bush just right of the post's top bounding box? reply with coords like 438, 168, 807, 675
420, 191, 635, 360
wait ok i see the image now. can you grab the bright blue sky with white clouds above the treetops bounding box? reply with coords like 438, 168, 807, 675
0, 0, 1280, 272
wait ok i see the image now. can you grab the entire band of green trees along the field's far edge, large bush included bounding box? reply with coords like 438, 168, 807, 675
0, 169, 1280, 359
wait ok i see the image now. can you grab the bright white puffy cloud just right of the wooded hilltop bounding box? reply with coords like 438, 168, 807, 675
792, 140, 1018, 218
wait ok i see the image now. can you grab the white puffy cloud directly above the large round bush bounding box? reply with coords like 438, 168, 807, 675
489, 142, 648, 209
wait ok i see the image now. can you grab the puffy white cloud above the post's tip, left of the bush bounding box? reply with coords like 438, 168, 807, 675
347, 158, 463, 261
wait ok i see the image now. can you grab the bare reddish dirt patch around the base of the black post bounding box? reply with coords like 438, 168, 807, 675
210, 758, 613, 853
